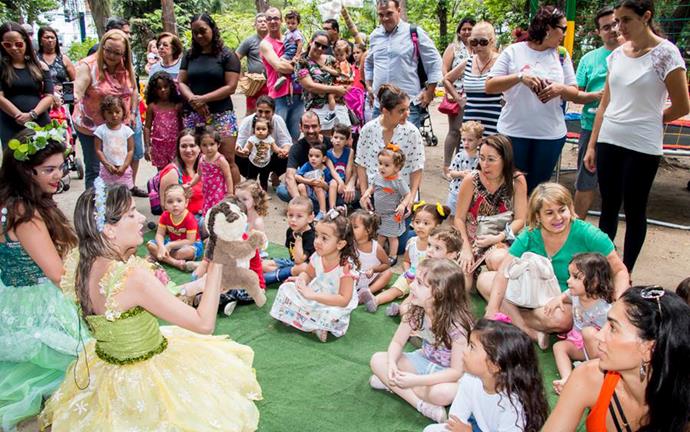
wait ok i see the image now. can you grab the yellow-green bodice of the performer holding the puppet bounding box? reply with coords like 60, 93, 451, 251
86, 306, 168, 365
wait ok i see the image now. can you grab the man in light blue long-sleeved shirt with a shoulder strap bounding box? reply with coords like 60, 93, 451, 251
364, 0, 443, 128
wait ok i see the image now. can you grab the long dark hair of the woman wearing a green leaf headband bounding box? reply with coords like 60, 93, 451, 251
0, 129, 77, 257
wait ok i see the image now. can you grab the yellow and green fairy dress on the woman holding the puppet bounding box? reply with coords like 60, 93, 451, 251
39, 253, 261, 432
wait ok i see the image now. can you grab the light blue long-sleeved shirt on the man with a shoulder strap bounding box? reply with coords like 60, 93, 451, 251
364, 21, 443, 106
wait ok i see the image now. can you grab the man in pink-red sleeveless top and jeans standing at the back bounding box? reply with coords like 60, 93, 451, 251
259, 7, 304, 142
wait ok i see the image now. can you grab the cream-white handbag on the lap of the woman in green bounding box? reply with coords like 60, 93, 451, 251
504, 252, 561, 309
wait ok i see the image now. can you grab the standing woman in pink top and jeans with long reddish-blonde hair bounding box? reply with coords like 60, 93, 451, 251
74, 30, 138, 189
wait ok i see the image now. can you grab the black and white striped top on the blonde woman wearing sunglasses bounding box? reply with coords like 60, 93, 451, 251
462, 57, 502, 136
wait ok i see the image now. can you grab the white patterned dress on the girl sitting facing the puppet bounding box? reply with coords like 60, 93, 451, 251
271, 253, 358, 337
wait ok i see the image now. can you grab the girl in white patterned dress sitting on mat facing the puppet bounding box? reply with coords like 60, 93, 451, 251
271, 209, 359, 342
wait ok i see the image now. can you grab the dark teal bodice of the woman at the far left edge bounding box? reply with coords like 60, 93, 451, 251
0, 208, 46, 286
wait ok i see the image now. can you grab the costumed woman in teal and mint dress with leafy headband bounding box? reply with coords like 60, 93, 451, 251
0, 127, 88, 430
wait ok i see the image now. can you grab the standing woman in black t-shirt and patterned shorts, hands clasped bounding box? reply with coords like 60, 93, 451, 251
178, 13, 240, 192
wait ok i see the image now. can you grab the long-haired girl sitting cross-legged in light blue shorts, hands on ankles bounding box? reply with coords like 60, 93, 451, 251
369, 258, 474, 423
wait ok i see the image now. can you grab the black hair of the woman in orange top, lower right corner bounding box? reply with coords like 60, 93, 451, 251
619, 286, 690, 432
